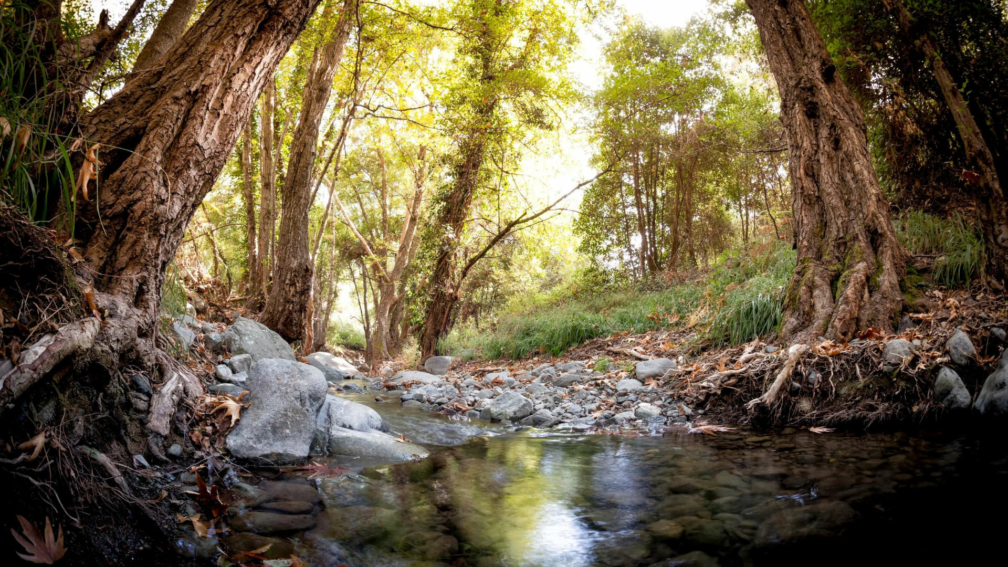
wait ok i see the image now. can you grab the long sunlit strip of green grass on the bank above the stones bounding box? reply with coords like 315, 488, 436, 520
438, 238, 794, 359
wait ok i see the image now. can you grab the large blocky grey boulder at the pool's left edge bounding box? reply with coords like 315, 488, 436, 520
227, 358, 327, 461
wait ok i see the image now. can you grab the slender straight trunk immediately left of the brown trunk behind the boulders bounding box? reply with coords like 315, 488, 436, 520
254, 77, 283, 305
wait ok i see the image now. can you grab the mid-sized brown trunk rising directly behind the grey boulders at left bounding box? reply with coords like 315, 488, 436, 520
260, 0, 357, 340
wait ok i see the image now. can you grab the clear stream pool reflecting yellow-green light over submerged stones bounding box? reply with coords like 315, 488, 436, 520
282, 396, 1008, 566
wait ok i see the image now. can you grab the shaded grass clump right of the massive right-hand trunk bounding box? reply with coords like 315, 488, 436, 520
894, 211, 986, 288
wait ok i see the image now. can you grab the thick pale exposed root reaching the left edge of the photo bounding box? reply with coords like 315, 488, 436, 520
0, 317, 101, 413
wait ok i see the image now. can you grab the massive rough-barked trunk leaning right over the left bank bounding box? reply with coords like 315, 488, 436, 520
79, 0, 319, 318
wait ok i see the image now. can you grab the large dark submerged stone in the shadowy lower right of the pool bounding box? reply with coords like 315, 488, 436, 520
753, 500, 857, 547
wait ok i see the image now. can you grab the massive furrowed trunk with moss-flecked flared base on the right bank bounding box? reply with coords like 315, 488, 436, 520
746, 0, 906, 342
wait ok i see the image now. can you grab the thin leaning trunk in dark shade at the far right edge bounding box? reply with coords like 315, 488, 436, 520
885, 0, 1008, 287
